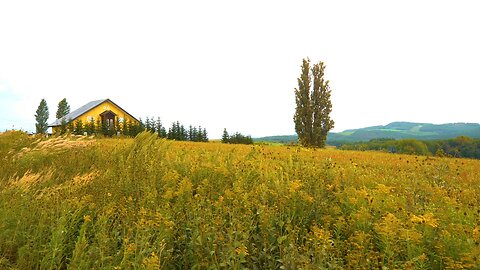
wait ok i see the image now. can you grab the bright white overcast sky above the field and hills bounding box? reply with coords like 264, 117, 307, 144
0, 0, 480, 138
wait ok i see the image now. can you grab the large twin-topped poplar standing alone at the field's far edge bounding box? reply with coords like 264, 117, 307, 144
293, 58, 334, 147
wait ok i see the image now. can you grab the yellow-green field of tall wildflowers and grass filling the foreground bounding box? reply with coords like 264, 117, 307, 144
0, 132, 480, 269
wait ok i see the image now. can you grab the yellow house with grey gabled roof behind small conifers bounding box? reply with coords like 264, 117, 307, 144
49, 98, 140, 134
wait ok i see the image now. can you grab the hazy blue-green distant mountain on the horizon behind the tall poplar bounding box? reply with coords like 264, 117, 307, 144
254, 122, 480, 145
